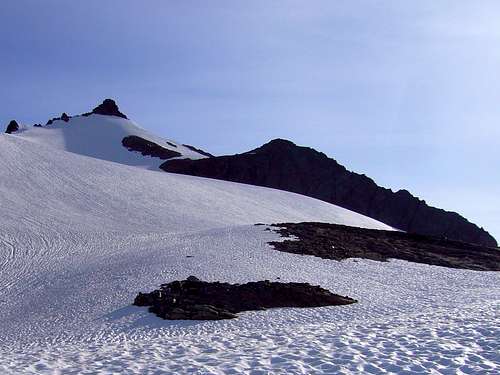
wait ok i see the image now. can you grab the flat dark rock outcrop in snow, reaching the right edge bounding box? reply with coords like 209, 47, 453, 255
270, 223, 500, 271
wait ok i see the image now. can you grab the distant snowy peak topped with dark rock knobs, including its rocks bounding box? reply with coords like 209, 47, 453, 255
6, 99, 211, 170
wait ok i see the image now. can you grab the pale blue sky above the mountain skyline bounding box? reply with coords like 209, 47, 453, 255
0, 0, 500, 239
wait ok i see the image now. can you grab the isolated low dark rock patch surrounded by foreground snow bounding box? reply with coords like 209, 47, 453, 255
134, 276, 357, 320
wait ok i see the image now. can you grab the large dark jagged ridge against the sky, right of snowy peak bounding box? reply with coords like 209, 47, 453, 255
160, 139, 497, 247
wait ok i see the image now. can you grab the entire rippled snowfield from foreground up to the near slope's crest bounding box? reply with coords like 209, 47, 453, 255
0, 136, 500, 374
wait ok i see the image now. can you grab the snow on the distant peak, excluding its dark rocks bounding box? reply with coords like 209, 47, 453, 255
15, 114, 206, 170
